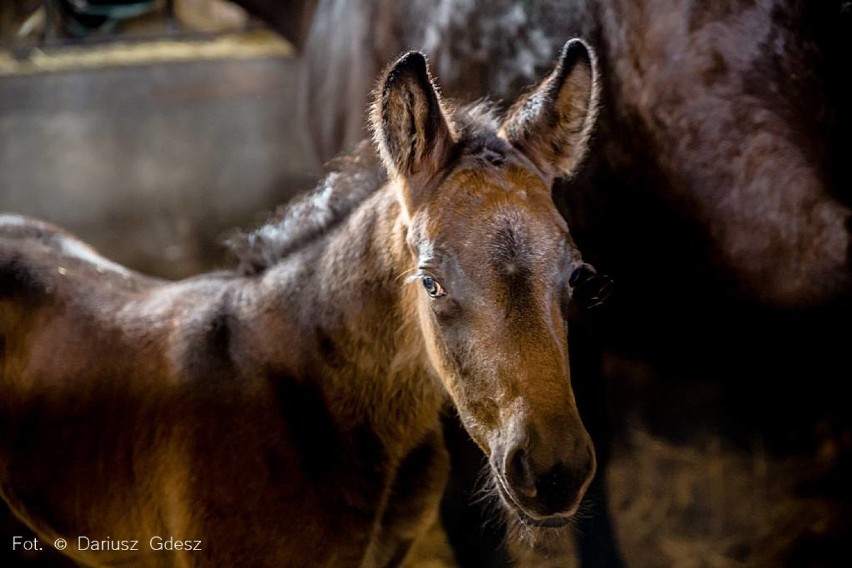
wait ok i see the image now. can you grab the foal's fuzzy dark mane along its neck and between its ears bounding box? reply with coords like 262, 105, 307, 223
226, 100, 506, 275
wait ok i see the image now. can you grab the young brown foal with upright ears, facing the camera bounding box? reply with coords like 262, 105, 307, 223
0, 40, 597, 567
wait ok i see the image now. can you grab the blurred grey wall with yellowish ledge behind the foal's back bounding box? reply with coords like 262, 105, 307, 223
0, 0, 320, 277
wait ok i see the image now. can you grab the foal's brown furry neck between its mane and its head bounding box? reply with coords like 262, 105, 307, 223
266, 182, 444, 446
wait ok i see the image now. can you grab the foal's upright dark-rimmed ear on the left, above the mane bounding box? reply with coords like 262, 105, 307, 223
372, 51, 454, 205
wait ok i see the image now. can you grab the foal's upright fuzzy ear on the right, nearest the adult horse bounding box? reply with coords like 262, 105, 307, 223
500, 39, 599, 178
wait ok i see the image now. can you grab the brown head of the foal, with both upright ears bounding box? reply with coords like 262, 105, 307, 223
373, 40, 597, 525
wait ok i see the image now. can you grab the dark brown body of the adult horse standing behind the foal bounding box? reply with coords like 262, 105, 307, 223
296, 0, 852, 308
